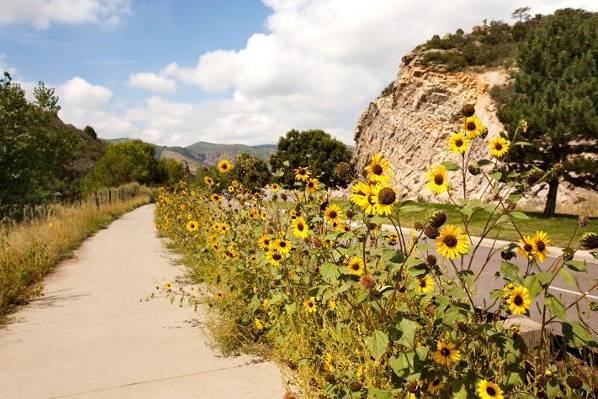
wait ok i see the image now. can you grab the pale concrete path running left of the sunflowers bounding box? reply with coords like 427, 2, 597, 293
0, 206, 284, 399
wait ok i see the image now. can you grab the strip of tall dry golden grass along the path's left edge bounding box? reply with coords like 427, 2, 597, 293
0, 192, 150, 314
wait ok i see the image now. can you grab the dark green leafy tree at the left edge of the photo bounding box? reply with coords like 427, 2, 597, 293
0, 72, 76, 218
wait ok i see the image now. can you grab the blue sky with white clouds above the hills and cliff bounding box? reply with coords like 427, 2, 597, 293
0, 0, 598, 146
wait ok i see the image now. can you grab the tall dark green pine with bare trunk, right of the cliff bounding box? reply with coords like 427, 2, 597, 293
497, 9, 598, 215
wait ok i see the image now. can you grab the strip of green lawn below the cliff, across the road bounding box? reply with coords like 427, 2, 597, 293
334, 200, 598, 247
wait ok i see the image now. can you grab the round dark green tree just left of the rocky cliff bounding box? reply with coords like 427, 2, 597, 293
270, 130, 351, 187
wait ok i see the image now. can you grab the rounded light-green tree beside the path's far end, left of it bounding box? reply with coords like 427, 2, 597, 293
82, 140, 158, 191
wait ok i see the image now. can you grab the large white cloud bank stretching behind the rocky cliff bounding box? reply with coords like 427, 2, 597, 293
29, 0, 598, 145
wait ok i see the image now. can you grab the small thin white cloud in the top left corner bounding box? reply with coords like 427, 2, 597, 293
0, 0, 129, 29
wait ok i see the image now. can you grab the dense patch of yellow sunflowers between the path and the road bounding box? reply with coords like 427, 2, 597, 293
156, 106, 598, 399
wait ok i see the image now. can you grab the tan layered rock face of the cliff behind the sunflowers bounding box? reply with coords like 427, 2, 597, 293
354, 50, 595, 216
